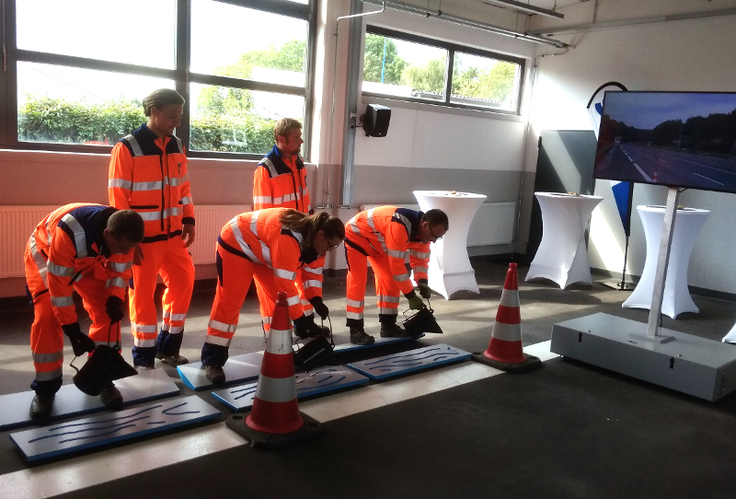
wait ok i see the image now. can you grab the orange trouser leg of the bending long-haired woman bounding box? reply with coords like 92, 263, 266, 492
202, 245, 254, 366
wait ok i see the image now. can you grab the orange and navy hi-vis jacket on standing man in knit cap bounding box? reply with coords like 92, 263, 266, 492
107, 124, 194, 243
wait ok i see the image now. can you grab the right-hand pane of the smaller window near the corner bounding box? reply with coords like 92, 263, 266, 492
450, 52, 521, 111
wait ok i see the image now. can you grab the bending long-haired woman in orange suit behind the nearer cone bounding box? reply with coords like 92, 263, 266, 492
197, 208, 345, 384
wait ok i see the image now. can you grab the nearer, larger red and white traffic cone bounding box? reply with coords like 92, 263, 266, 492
227, 292, 321, 447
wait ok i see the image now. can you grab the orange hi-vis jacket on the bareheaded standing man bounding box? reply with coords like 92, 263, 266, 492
253, 146, 310, 213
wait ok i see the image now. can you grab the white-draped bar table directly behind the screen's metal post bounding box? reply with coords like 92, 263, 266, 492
622, 205, 710, 319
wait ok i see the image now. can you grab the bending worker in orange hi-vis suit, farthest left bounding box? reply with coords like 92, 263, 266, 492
25, 203, 144, 419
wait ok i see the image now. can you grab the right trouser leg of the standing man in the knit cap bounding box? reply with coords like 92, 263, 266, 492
156, 237, 194, 355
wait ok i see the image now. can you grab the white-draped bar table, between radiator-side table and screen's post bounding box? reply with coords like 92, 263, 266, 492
525, 192, 603, 289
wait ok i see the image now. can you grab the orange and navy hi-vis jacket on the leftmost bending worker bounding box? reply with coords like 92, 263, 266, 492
26, 203, 133, 326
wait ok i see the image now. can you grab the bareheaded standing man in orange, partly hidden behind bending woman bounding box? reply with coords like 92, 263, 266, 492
253, 118, 327, 331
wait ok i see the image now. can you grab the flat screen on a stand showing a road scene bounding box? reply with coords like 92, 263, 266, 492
593, 91, 736, 192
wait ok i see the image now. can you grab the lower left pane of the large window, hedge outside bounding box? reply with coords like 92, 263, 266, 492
18, 62, 174, 144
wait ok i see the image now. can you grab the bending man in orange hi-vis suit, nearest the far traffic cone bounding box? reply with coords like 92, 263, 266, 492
345, 206, 449, 345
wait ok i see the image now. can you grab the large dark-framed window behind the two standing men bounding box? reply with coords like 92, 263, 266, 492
0, 0, 316, 158
